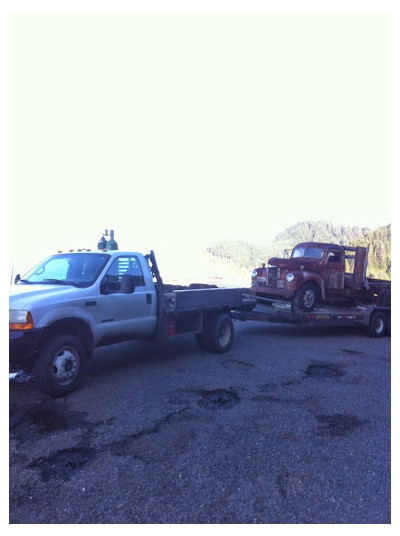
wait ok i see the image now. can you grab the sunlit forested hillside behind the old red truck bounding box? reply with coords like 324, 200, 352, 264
207, 221, 391, 279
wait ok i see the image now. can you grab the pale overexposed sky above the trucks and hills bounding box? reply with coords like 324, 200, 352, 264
9, 5, 391, 272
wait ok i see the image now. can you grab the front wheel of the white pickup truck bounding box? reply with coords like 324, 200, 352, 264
34, 334, 87, 397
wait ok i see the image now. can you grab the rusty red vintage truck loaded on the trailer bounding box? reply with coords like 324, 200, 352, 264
251, 242, 391, 312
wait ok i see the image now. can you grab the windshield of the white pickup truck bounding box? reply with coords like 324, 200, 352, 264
21, 253, 110, 287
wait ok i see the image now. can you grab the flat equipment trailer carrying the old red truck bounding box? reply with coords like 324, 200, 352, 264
232, 297, 391, 337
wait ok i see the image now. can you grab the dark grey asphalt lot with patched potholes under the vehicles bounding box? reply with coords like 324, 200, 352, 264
10, 322, 391, 524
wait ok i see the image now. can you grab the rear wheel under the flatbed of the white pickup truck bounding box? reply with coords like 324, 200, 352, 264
196, 313, 234, 354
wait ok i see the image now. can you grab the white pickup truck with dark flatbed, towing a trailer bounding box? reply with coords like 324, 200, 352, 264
9, 250, 256, 396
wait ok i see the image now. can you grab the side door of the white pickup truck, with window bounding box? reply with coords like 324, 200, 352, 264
98, 255, 157, 338
